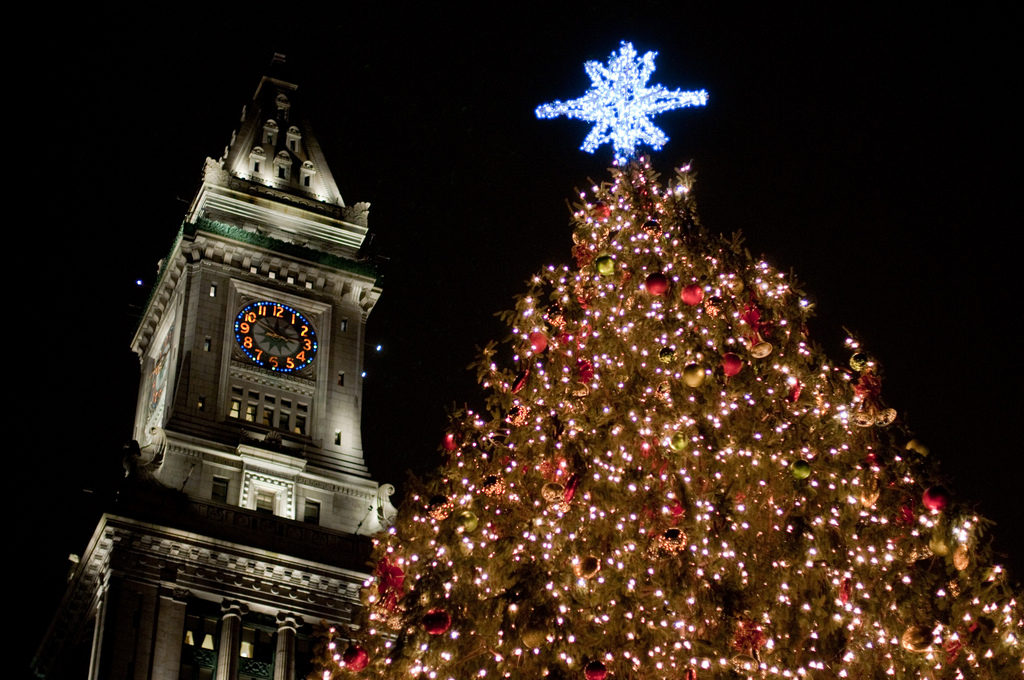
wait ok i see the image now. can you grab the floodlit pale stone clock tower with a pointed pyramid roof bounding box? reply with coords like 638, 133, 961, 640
34, 59, 394, 680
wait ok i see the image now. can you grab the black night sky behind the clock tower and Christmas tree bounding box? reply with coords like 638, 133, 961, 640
24, 2, 1024, 675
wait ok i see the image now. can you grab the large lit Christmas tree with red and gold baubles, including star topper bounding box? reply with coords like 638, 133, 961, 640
317, 44, 1024, 680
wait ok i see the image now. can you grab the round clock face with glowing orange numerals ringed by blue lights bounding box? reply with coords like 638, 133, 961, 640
234, 300, 317, 373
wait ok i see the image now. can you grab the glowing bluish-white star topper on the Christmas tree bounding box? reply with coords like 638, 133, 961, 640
537, 42, 708, 164
